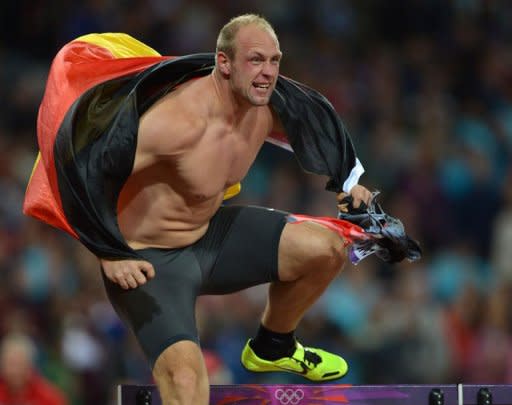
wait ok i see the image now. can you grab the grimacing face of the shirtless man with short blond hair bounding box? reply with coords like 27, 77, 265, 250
230, 25, 281, 106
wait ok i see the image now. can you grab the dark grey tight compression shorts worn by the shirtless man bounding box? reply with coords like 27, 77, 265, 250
102, 206, 288, 367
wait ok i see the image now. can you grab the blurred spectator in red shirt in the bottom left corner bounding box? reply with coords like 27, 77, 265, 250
0, 334, 68, 405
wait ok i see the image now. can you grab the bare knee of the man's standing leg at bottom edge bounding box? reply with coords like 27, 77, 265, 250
153, 341, 210, 405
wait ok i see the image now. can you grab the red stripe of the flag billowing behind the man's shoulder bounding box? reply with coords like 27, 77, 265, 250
23, 41, 170, 237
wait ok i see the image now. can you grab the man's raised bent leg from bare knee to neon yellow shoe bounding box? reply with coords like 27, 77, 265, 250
241, 218, 348, 382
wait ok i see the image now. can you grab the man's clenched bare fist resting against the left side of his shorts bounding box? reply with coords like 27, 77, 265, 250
100, 259, 155, 290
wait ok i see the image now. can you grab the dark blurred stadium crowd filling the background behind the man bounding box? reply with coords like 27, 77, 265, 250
0, 0, 512, 405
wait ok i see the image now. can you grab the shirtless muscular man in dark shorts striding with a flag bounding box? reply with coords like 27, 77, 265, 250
101, 15, 371, 405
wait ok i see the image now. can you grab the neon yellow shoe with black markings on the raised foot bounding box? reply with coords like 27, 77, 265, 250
241, 340, 348, 381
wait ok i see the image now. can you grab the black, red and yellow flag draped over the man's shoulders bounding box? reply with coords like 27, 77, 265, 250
23, 33, 356, 258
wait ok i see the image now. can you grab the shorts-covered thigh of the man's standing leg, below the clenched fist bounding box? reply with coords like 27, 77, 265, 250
103, 248, 201, 366
